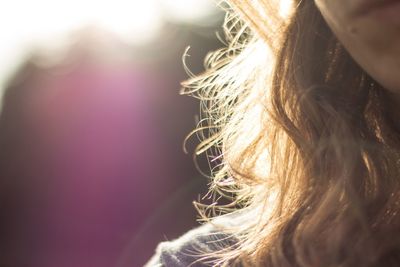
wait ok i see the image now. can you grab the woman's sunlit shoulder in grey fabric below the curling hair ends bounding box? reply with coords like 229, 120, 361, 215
145, 223, 236, 267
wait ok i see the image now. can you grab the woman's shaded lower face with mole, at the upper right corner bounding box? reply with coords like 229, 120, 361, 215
315, 0, 400, 94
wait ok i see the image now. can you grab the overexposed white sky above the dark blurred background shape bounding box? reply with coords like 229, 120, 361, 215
0, 0, 216, 90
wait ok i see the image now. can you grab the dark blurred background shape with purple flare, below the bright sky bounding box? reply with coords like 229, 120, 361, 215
0, 14, 223, 267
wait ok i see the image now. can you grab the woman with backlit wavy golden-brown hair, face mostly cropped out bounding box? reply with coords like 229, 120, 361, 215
148, 0, 400, 267
